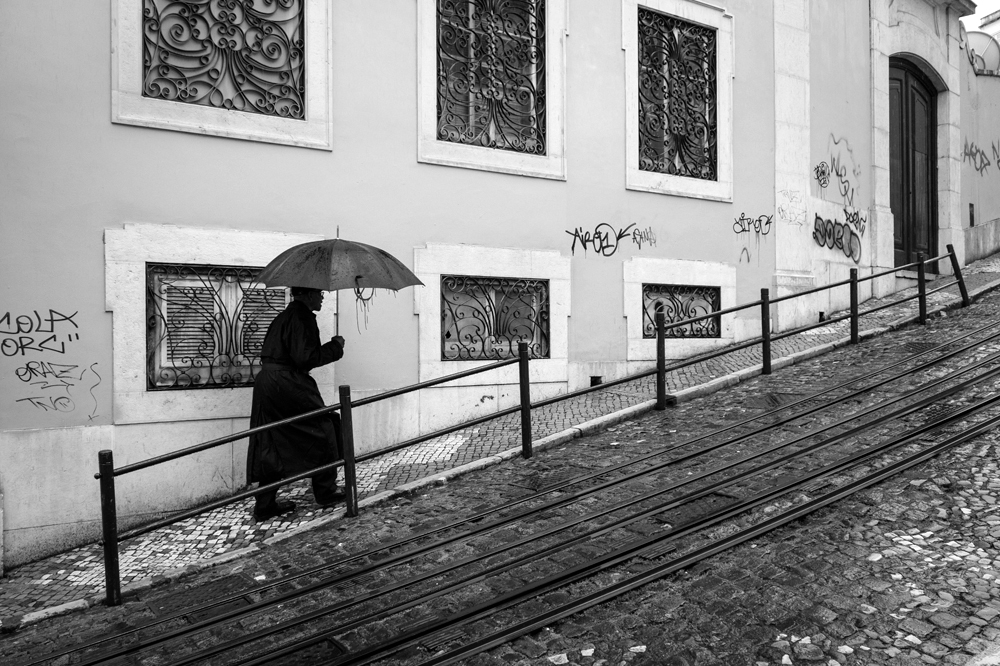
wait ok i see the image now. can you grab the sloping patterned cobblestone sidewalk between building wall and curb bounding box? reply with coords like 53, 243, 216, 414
0, 255, 1000, 630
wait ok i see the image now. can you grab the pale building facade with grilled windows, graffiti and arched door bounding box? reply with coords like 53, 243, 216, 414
0, 0, 1000, 566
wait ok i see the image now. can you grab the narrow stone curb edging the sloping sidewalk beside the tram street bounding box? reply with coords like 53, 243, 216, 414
0, 280, 1000, 633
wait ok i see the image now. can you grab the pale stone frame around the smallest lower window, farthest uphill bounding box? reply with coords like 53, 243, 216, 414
622, 257, 736, 361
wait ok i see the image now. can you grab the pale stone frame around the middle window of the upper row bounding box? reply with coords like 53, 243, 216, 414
417, 0, 568, 180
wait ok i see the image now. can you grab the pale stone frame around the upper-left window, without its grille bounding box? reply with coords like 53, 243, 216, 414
111, 0, 333, 150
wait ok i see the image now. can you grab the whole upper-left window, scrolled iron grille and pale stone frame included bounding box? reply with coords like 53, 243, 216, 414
111, 0, 332, 150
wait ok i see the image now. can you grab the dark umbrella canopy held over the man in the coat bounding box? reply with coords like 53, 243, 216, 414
257, 238, 423, 291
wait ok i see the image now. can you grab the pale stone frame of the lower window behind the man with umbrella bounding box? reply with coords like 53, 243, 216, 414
104, 223, 337, 424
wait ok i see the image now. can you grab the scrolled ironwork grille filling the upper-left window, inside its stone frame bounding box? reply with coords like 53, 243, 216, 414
142, 0, 305, 120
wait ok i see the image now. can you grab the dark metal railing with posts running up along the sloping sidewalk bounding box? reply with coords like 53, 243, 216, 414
94, 245, 969, 606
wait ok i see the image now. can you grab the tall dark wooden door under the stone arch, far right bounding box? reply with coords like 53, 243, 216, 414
889, 58, 938, 266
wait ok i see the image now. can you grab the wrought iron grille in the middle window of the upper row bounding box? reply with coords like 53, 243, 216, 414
437, 0, 545, 155
